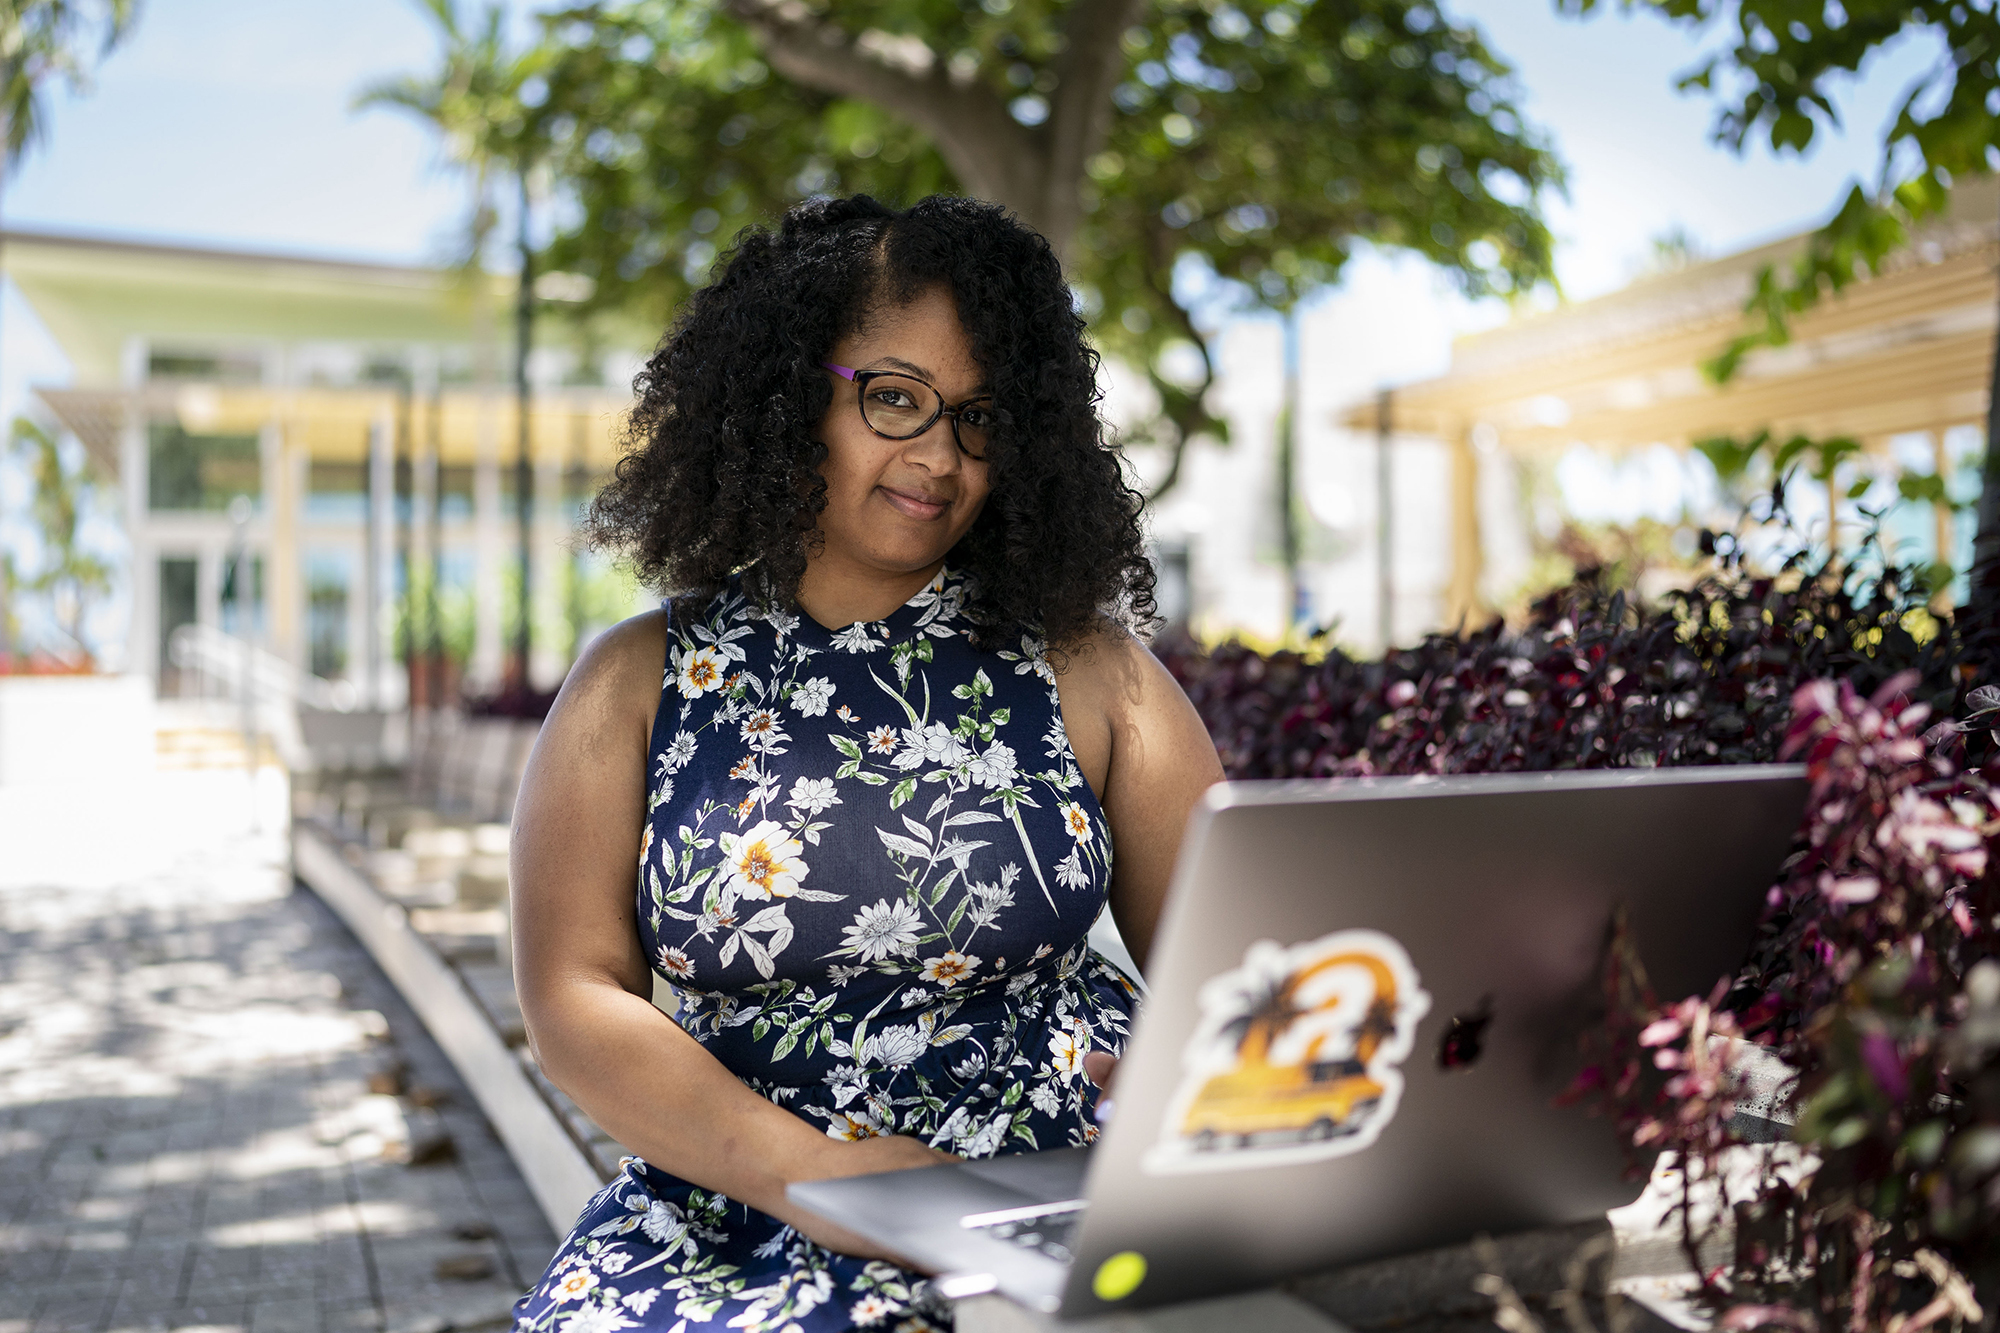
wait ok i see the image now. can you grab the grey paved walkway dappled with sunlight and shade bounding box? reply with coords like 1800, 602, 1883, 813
0, 773, 556, 1333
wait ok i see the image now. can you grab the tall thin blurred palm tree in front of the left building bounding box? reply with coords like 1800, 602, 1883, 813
356, 0, 550, 691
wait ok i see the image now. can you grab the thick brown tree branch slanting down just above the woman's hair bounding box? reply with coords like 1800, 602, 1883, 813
728, 0, 1042, 220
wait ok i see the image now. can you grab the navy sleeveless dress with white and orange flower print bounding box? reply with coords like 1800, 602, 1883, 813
514, 572, 1136, 1333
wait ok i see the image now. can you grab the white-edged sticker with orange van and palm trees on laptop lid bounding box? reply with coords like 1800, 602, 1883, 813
1146, 931, 1430, 1173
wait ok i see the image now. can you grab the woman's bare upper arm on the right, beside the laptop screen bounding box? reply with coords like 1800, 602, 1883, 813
1056, 628, 1222, 971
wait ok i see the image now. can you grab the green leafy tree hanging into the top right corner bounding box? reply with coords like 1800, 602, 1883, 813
1556, 0, 2000, 628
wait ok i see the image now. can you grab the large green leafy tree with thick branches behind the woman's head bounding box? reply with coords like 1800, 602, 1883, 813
544, 0, 1560, 490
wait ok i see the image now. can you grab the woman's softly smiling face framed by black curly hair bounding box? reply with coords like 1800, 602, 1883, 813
816, 286, 988, 576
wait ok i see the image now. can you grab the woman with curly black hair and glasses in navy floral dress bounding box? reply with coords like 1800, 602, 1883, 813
512, 196, 1220, 1333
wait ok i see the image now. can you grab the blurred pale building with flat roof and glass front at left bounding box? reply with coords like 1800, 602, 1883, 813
0, 232, 652, 707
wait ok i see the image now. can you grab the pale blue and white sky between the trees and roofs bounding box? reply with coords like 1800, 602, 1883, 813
0, 0, 1952, 640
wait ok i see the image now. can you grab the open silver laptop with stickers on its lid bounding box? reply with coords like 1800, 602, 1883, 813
788, 765, 1806, 1317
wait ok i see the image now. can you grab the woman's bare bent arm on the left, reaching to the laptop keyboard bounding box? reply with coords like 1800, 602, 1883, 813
508, 612, 942, 1255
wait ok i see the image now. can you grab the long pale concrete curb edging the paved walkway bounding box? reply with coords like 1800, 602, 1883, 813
292, 823, 604, 1235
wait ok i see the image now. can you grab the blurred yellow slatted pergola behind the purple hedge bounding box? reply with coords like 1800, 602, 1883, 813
1338, 180, 2000, 620
